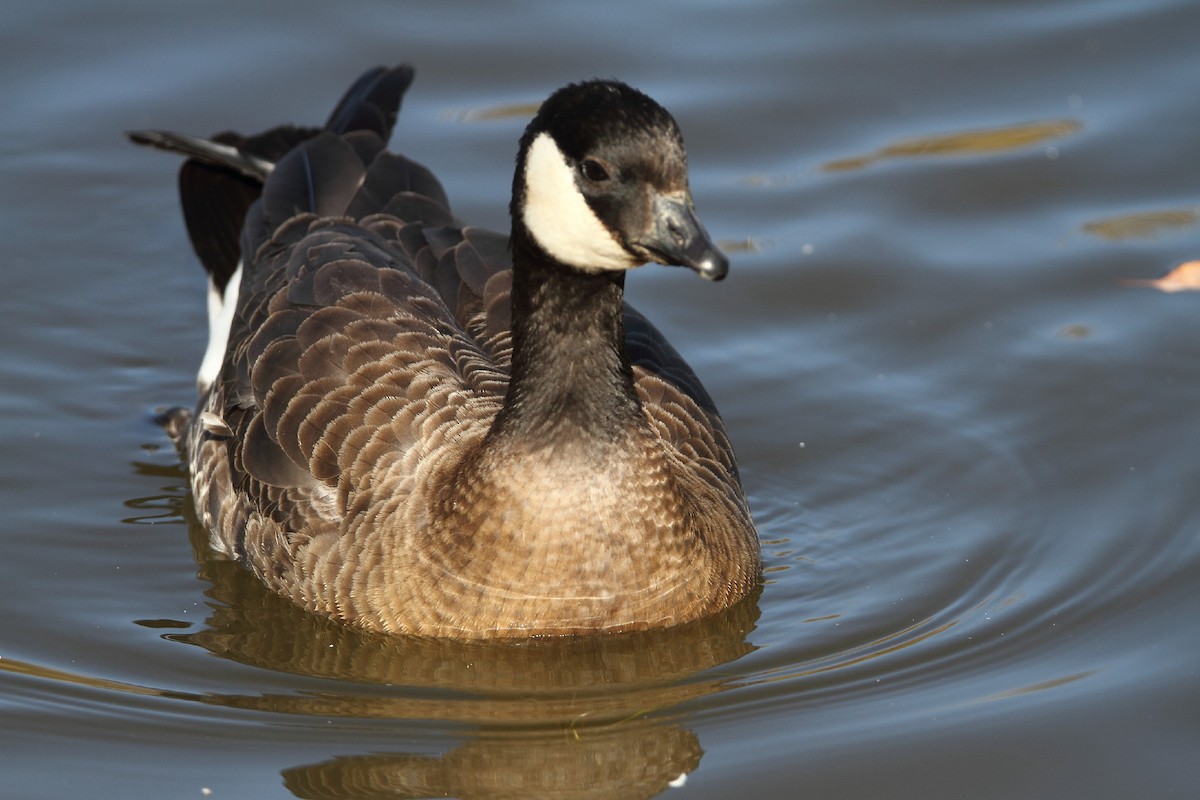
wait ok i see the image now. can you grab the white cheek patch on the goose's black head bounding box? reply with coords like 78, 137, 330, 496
523, 133, 643, 272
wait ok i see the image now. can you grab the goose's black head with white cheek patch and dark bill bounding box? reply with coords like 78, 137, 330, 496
511, 80, 728, 281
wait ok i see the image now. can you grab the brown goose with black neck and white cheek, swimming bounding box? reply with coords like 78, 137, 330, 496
128, 65, 761, 639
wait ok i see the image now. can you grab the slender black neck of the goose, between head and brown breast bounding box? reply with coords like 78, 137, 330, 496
492, 225, 642, 441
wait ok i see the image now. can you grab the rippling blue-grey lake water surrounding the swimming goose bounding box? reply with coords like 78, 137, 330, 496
0, 0, 1200, 799
